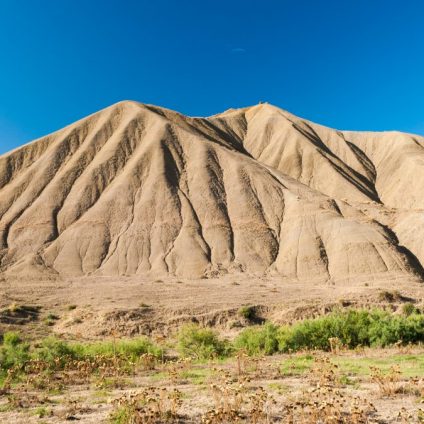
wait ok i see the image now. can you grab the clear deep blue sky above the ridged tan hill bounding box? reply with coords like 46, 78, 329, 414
0, 0, 424, 153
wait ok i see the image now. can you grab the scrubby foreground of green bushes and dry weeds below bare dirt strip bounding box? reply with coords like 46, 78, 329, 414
0, 298, 424, 424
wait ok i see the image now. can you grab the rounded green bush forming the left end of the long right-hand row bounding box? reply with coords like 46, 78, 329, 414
234, 323, 279, 355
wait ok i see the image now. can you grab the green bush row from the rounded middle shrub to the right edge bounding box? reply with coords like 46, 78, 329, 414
178, 309, 424, 359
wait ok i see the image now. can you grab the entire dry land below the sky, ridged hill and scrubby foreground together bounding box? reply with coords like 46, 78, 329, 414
0, 102, 424, 424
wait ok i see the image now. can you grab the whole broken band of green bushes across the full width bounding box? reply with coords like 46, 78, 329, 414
0, 309, 424, 373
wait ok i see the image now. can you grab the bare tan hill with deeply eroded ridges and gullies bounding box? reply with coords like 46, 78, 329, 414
0, 102, 424, 281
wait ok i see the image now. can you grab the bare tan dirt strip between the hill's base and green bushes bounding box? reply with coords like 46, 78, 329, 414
0, 274, 424, 338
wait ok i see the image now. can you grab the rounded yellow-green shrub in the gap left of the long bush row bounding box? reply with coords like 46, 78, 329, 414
178, 324, 228, 359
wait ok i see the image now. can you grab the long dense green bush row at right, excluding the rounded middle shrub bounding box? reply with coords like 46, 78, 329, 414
234, 309, 424, 355
